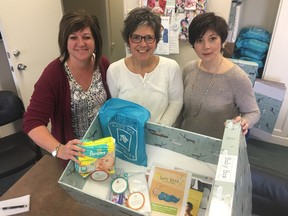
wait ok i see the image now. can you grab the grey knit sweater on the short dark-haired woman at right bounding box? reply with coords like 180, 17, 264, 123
180, 61, 260, 139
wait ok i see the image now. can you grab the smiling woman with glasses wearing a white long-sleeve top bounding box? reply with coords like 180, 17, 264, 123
107, 8, 183, 126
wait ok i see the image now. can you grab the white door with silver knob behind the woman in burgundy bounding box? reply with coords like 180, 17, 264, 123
0, 0, 63, 107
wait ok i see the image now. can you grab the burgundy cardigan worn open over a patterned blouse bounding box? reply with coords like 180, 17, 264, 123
23, 57, 110, 144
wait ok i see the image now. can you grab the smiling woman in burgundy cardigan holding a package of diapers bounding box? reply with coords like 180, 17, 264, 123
23, 10, 110, 162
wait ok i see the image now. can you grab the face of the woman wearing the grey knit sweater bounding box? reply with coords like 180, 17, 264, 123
194, 30, 222, 61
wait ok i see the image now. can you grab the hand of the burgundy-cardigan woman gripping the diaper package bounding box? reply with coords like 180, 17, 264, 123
57, 139, 85, 164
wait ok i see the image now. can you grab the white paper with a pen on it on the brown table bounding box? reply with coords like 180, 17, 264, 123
0, 194, 30, 216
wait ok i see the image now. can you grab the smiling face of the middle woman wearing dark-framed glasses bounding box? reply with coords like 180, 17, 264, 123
129, 25, 157, 61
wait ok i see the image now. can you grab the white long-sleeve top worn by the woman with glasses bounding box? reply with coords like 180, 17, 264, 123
107, 56, 183, 126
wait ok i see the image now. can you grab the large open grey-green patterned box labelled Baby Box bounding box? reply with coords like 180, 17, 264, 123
58, 118, 252, 216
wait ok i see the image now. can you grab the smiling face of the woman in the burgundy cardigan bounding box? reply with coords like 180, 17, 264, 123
67, 27, 95, 61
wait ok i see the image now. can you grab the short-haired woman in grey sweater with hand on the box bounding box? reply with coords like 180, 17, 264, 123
180, 12, 260, 139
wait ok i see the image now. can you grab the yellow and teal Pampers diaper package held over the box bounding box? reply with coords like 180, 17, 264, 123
75, 137, 115, 177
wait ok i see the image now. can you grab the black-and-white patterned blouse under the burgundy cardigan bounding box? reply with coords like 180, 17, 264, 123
64, 62, 107, 139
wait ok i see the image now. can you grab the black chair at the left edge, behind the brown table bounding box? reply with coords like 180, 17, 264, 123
0, 91, 42, 179
